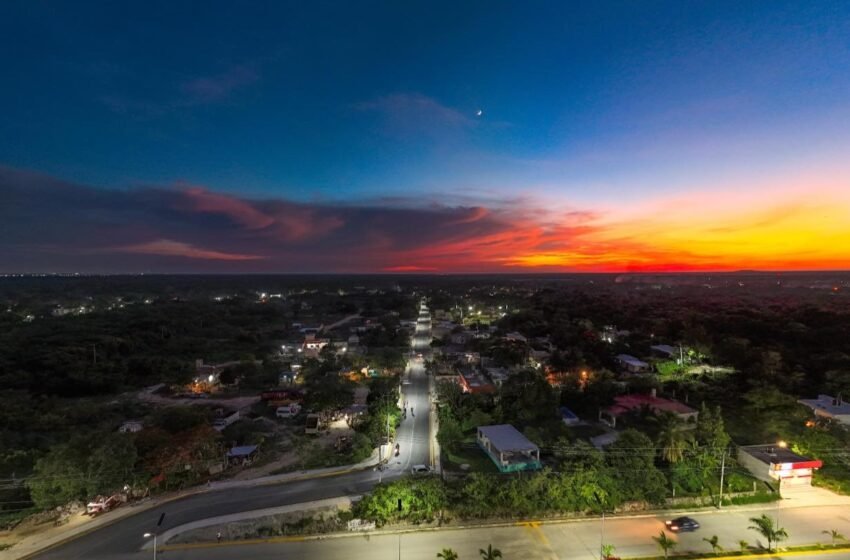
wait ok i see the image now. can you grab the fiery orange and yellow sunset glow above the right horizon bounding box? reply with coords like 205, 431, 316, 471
380, 180, 850, 272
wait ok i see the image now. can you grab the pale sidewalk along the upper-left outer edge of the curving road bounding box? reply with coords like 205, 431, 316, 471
0, 451, 378, 560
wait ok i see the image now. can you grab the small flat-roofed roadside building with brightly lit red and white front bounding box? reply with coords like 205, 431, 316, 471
738, 442, 823, 495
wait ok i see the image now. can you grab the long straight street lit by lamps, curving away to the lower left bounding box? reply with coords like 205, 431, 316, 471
32, 311, 431, 560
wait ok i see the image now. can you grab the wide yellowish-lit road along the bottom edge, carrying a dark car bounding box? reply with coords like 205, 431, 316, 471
165, 506, 850, 560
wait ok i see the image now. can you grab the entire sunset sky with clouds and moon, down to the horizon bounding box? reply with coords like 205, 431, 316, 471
0, 0, 850, 273
